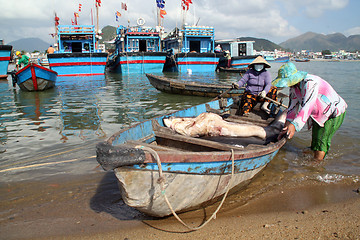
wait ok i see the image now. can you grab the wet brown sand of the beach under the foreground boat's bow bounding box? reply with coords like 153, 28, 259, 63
0, 171, 360, 240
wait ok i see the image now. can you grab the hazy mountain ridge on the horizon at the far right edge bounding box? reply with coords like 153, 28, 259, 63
280, 32, 360, 52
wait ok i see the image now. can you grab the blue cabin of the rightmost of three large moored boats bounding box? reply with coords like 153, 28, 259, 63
163, 26, 215, 53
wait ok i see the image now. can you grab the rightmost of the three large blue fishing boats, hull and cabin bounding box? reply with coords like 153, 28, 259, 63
163, 25, 219, 72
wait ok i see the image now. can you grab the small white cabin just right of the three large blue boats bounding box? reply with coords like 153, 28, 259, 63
215, 39, 255, 57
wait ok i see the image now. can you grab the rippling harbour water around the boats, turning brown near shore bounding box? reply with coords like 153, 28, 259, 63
0, 61, 360, 214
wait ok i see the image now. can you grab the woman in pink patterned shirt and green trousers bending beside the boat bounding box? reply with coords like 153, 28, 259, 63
272, 62, 347, 160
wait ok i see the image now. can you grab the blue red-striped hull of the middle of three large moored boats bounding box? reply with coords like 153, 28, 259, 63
107, 52, 166, 74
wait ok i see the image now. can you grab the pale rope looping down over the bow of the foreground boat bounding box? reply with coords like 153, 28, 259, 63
135, 145, 235, 231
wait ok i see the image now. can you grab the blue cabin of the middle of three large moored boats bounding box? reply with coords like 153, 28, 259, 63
115, 26, 161, 53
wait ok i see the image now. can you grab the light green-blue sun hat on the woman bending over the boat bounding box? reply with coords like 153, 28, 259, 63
271, 62, 307, 87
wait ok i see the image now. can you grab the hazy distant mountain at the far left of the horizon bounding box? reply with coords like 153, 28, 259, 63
8, 38, 51, 52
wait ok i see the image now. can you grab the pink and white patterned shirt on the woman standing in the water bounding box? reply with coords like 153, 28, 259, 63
286, 74, 347, 131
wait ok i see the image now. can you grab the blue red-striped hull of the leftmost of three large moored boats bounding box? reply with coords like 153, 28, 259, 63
48, 53, 107, 77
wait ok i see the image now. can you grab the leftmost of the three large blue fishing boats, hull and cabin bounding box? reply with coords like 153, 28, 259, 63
47, 25, 107, 77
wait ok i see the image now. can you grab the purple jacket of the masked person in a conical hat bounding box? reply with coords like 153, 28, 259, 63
238, 69, 271, 95
